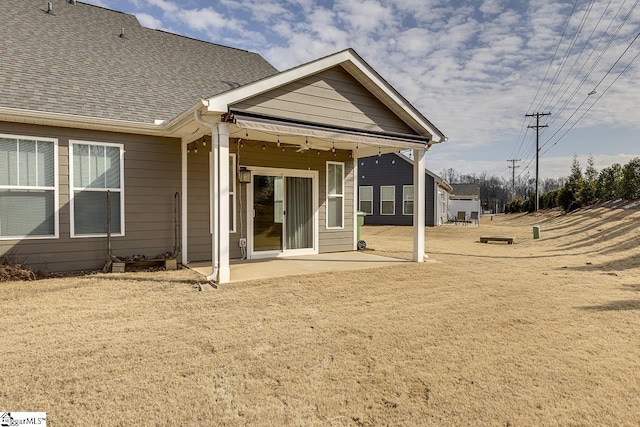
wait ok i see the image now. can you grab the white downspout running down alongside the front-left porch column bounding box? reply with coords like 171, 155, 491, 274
193, 110, 220, 282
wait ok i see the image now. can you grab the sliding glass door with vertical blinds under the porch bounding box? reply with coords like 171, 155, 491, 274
251, 170, 317, 257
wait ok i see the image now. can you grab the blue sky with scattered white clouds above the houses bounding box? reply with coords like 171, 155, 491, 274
84, 0, 640, 180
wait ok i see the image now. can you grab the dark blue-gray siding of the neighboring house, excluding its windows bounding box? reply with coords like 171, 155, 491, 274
358, 153, 437, 226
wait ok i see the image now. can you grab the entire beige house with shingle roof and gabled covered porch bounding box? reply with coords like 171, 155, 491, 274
0, 0, 445, 283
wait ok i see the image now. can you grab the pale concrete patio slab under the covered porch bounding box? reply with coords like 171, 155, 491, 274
187, 251, 409, 282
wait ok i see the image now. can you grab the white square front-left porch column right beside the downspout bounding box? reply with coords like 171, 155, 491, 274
219, 123, 231, 283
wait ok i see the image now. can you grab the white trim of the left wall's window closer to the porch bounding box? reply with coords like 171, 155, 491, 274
69, 139, 125, 239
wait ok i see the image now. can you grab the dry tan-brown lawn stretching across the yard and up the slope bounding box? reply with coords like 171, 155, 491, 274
0, 207, 640, 426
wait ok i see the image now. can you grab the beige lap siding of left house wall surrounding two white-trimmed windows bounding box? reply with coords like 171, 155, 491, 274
0, 122, 180, 271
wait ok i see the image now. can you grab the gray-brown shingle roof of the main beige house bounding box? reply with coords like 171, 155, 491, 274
0, 0, 278, 123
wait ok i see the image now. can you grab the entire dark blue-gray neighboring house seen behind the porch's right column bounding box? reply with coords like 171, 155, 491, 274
358, 152, 451, 226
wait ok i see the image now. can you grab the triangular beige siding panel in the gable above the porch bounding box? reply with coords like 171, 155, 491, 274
232, 66, 416, 135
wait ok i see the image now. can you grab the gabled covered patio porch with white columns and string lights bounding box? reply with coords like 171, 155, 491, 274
172, 50, 446, 283
